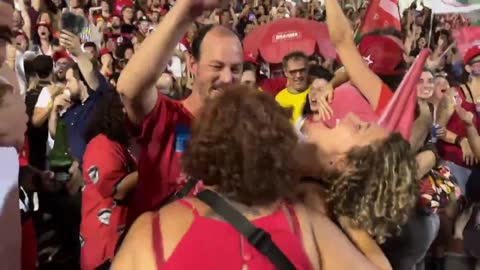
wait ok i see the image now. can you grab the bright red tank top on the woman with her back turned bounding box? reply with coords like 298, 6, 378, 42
152, 200, 313, 270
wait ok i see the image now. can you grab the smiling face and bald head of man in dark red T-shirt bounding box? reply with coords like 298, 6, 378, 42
190, 27, 243, 100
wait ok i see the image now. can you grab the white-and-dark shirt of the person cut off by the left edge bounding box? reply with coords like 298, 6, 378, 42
0, 147, 22, 270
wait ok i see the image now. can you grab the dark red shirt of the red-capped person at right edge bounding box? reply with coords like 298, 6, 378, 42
438, 86, 479, 168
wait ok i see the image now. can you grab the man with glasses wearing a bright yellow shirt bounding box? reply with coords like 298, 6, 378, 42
275, 51, 310, 124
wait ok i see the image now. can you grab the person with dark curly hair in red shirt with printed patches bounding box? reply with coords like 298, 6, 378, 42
80, 92, 138, 269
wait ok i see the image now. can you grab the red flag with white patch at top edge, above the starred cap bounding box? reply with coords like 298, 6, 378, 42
360, 0, 402, 34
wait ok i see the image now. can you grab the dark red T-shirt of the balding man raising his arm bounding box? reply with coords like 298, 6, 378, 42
127, 94, 193, 228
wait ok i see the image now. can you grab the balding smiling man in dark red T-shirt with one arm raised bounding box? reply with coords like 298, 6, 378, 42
117, 0, 243, 228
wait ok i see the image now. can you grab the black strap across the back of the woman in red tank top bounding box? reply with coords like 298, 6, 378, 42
197, 190, 295, 270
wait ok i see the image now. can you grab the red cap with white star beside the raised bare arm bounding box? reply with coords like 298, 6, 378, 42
358, 35, 405, 75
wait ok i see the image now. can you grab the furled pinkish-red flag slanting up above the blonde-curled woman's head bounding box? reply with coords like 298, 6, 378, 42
378, 49, 431, 140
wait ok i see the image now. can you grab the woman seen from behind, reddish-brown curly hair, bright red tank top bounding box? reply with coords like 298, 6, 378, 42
112, 85, 376, 270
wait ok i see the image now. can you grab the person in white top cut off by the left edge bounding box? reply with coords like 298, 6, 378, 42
0, 0, 27, 269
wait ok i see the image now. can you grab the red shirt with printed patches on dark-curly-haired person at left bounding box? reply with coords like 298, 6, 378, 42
80, 134, 135, 270
